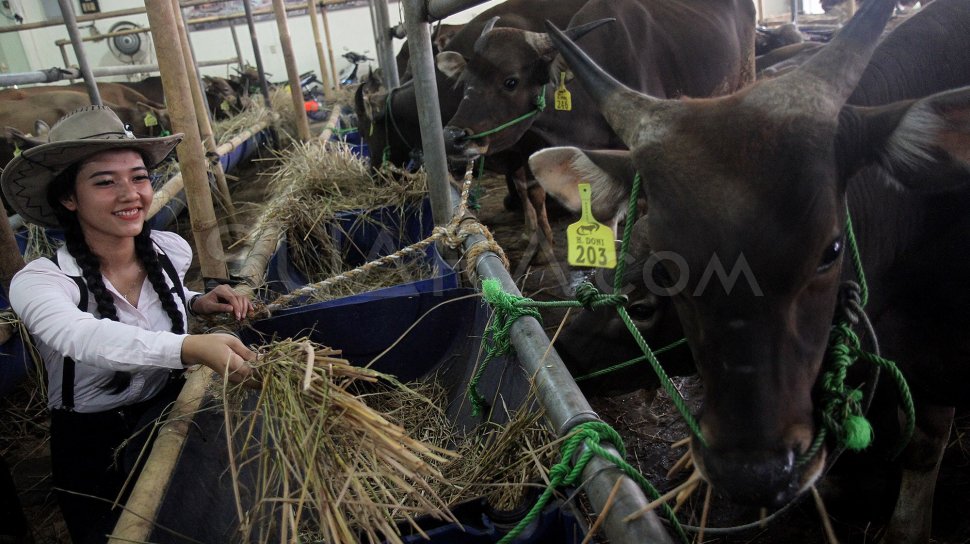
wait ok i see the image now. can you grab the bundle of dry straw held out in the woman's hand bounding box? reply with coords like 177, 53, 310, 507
227, 340, 558, 544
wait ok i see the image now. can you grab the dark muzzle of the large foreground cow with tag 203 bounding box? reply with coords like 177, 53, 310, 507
693, 444, 824, 508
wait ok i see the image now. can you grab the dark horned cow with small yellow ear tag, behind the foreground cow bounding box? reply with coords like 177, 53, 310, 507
438, 0, 755, 159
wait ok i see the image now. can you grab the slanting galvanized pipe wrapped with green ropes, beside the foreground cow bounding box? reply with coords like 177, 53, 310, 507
464, 230, 673, 544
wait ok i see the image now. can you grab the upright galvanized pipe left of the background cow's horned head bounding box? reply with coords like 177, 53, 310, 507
403, 0, 454, 225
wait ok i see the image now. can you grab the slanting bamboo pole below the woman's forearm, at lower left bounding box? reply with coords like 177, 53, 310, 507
108, 368, 212, 544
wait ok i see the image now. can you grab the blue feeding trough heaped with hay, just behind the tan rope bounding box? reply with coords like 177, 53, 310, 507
266, 199, 458, 306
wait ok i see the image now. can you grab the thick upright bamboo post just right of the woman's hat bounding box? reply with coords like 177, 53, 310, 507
145, 0, 228, 279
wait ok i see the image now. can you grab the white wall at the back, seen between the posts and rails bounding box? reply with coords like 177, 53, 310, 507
5, 0, 501, 81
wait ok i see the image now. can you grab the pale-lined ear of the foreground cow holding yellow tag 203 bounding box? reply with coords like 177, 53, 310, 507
529, 147, 635, 227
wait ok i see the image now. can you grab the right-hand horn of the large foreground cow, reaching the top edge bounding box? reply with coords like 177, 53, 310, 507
793, 0, 896, 110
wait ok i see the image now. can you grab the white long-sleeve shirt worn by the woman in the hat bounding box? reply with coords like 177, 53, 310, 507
10, 231, 196, 412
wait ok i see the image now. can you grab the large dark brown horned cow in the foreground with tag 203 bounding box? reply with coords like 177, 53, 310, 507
546, 0, 970, 542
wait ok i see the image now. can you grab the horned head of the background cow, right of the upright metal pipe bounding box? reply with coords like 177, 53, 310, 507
436, 17, 612, 161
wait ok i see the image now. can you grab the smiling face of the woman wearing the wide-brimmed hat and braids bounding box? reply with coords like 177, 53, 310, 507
62, 149, 154, 243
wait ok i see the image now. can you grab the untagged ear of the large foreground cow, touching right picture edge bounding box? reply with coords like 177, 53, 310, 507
855, 87, 970, 190
